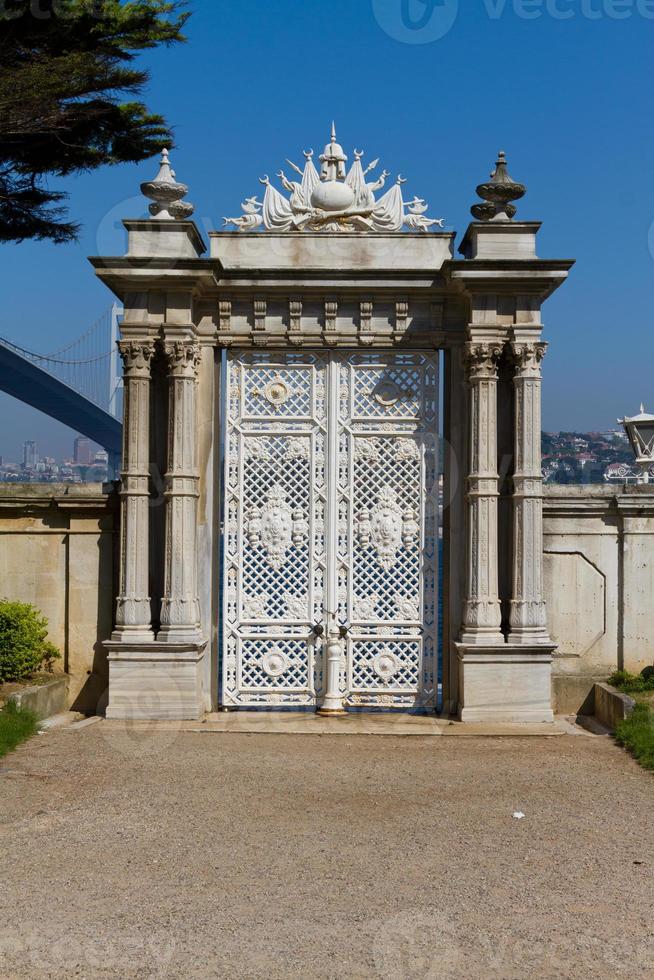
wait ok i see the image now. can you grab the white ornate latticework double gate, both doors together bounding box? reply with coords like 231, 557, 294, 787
221, 351, 438, 708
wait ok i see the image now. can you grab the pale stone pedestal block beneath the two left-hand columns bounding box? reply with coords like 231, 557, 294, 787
104, 640, 207, 721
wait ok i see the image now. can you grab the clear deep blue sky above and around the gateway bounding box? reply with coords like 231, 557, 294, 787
0, 0, 654, 457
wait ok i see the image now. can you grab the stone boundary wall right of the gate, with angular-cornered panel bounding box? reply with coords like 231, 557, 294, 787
543, 485, 654, 713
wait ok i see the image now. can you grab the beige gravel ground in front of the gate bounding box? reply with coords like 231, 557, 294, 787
0, 722, 654, 980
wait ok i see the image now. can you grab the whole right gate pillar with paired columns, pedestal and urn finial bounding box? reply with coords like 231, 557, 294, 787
449, 182, 572, 722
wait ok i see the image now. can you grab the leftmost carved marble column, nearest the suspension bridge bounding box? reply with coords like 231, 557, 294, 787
112, 338, 154, 642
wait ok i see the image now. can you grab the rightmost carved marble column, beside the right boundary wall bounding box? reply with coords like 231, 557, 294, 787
509, 341, 550, 645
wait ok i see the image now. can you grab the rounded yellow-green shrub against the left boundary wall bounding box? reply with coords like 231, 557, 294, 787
0, 599, 61, 683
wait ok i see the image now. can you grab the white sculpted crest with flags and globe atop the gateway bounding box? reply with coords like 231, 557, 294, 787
223, 124, 444, 232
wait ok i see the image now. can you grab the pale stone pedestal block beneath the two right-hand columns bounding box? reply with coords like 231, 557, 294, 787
455, 641, 556, 724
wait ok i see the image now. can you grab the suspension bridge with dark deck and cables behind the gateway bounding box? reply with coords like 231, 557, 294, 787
0, 304, 123, 466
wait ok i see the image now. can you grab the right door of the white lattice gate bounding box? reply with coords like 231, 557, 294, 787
336, 352, 438, 708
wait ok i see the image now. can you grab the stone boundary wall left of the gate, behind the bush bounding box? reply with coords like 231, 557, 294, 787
0, 483, 118, 713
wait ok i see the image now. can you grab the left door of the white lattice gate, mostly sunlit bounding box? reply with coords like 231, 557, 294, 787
221, 352, 329, 707
